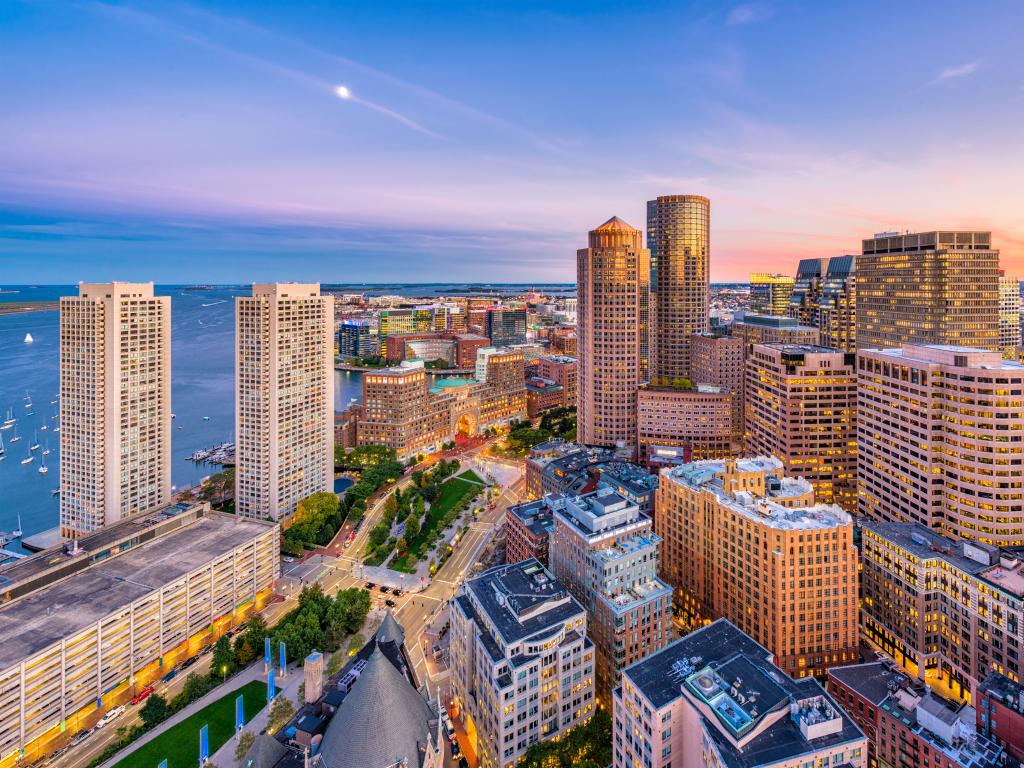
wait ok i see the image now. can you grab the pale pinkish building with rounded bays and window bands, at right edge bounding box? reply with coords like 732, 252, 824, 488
857, 344, 1024, 546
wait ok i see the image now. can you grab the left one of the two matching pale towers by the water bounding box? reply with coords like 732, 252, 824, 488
60, 283, 171, 538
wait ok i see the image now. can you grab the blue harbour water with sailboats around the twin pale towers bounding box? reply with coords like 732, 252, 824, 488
0, 286, 362, 550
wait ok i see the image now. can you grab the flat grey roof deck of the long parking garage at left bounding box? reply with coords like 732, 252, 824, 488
0, 513, 268, 670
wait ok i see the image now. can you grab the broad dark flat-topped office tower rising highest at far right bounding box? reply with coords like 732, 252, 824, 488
857, 231, 999, 349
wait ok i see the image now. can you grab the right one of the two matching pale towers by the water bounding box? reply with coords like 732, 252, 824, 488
234, 283, 334, 520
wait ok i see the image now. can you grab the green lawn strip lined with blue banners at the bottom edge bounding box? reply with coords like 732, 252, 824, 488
115, 680, 266, 768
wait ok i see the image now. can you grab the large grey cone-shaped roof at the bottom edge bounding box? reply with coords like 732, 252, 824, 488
321, 647, 437, 768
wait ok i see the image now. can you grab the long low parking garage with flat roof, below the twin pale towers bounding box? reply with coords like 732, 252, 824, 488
0, 504, 281, 768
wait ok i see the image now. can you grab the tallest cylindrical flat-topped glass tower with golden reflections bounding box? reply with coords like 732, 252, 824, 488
647, 195, 711, 381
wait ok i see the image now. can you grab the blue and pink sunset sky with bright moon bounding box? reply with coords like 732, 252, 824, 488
0, 0, 1024, 285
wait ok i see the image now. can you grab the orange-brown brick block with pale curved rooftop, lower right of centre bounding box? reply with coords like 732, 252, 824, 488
654, 457, 857, 677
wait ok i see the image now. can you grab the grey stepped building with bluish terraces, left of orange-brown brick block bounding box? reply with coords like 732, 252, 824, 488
548, 487, 672, 701
